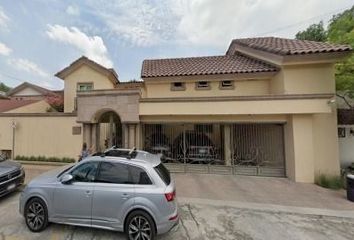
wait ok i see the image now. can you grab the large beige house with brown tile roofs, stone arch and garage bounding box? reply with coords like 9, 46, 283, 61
0, 37, 351, 182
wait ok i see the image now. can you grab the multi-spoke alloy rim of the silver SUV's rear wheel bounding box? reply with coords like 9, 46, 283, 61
128, 216, 151, 240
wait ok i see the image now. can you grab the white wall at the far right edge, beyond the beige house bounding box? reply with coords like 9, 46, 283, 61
338, 125, 354, 167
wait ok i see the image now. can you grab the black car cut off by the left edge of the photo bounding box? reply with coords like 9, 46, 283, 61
0, 156, 25, 197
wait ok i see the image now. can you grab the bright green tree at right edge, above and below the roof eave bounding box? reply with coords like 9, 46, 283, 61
328, 6, 354, 92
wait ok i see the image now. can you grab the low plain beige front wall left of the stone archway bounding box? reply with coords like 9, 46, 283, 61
0, 116, 82, 159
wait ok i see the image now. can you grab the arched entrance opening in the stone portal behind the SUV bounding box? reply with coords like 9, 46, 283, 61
97, 111, 123, 151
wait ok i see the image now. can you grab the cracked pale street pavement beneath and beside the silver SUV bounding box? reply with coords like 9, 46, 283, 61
0, 189, 354, 240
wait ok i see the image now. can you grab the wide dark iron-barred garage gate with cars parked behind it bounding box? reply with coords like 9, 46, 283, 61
143, 123, 285, 177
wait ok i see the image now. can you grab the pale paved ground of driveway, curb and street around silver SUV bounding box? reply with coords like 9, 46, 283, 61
0, 165, 354, 240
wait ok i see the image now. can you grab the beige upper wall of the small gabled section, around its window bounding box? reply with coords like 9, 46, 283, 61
64, 65, 114, 113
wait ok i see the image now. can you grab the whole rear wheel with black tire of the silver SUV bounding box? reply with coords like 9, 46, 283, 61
124, 210, 156, 240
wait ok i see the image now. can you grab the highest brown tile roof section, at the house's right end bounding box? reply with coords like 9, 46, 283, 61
228, 37, 352, 55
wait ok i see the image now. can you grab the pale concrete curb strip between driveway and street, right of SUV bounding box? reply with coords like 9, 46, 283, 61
177, 197, 354, 219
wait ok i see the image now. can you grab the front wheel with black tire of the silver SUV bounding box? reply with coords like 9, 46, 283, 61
24, 198, 48, 232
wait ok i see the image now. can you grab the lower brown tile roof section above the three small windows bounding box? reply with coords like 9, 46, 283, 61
141, 54, 278, 78
